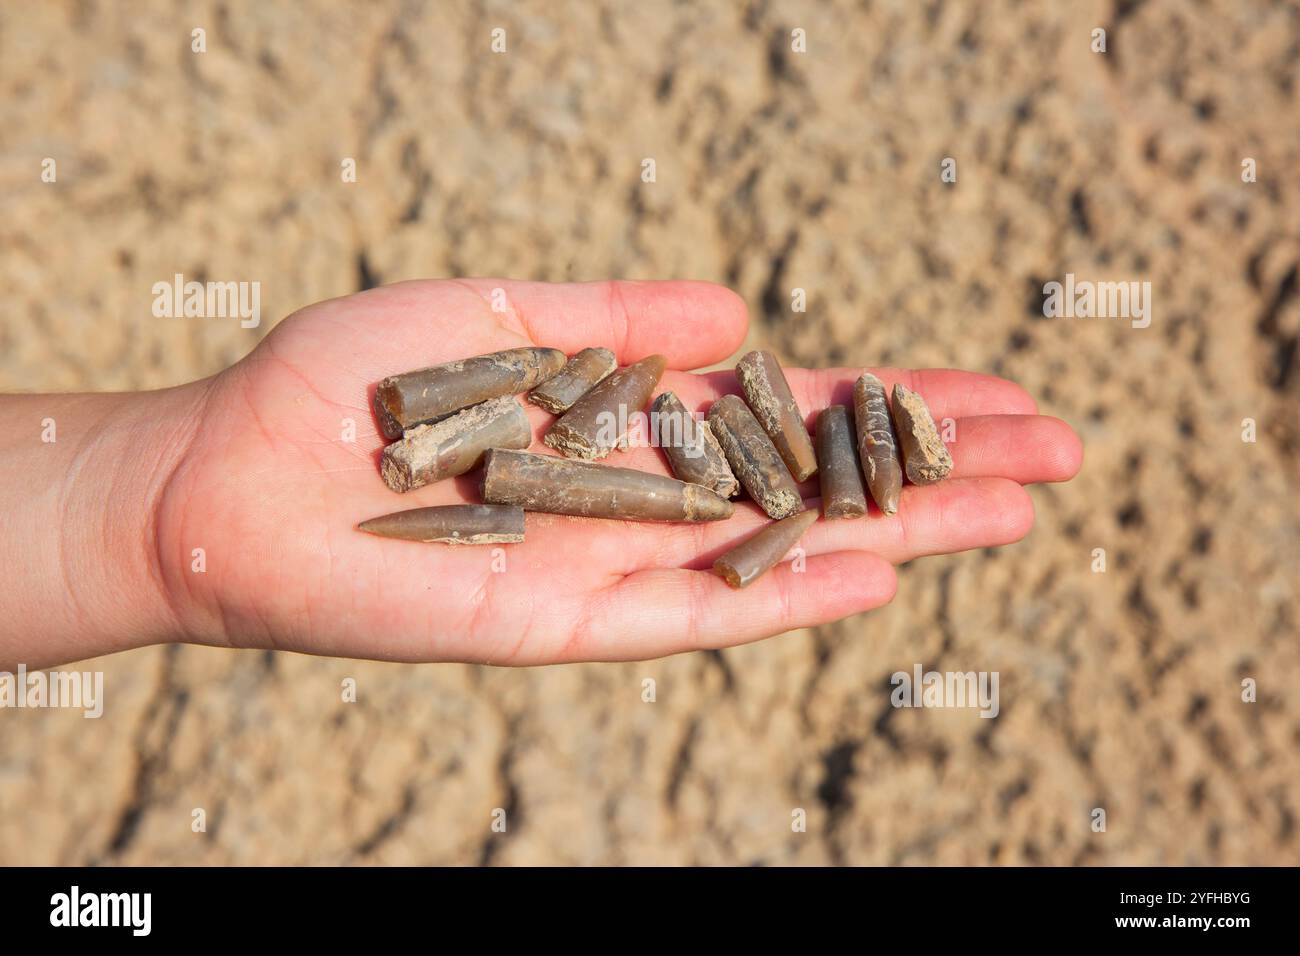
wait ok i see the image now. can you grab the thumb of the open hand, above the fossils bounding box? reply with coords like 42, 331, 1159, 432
467, 280, 749, 368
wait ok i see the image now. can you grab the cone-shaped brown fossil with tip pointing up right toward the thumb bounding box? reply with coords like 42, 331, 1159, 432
543, 355, 667, 460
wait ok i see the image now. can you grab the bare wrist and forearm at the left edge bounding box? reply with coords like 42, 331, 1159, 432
0, 382, 208, 669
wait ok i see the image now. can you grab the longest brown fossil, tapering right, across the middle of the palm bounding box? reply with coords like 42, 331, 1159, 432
484, 449, 735, 522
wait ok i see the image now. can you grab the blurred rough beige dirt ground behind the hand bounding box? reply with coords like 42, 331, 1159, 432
0, 0, 1300, 865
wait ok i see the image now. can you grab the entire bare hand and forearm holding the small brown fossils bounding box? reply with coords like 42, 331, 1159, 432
0, 280, 1082, 671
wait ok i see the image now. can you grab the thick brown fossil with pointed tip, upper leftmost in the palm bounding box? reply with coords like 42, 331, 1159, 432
374, 347, 564, 438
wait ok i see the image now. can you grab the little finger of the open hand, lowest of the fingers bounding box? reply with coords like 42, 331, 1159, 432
564, 551, 897, 661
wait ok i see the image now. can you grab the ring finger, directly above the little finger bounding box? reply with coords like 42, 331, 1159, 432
639, 477, 1034, 568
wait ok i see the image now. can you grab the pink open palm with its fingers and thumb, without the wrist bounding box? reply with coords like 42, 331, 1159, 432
157, 280, 1080, 665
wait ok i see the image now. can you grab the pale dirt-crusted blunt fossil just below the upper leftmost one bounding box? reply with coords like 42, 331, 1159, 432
380, 395, 533, 492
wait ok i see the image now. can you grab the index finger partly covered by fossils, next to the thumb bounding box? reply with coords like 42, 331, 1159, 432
681, 368, 1037, 427
